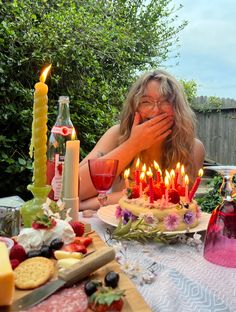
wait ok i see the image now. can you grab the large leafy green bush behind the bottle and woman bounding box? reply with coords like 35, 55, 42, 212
0, 0, 185, 199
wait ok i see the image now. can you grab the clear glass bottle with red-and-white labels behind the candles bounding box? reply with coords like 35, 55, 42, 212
47, 96, 76, 201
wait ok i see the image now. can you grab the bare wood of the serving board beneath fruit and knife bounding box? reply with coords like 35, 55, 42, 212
15, 232, 151, 312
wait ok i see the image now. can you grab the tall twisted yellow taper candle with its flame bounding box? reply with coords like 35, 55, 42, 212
31, 65, 51, 187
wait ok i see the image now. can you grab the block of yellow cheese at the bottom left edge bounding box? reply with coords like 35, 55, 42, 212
0, 242, 15, 306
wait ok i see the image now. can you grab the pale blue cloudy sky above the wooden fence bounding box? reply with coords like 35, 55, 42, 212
164, 0, 236, 99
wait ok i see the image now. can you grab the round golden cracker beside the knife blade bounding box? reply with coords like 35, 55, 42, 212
14, 257, 54, 289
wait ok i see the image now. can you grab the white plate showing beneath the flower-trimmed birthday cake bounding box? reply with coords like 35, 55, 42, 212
97, 205, 211, 234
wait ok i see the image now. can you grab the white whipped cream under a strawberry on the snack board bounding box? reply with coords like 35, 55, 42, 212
16, 219, 75, 252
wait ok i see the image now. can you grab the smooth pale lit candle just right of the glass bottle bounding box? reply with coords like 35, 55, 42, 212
63, 129, 80, 221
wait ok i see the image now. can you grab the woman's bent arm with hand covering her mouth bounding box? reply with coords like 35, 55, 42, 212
80, 113, 173, 201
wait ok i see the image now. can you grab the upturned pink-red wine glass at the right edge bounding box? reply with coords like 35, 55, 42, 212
204, 166, 236, 268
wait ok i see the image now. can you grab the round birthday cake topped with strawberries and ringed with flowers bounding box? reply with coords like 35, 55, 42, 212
116, 168, 201, 232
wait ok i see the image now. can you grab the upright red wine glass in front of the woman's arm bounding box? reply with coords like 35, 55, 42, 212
88, 158, 119, 207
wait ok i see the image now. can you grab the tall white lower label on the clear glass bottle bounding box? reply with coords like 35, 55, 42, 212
51, 154, 65, 200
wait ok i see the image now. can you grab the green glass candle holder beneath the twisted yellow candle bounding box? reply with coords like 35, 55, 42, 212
20, 184, 51, 227
